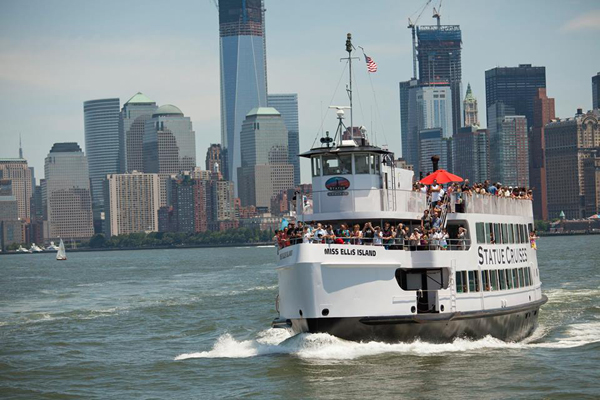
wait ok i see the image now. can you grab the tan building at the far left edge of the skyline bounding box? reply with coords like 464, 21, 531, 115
0, 158, 33, 220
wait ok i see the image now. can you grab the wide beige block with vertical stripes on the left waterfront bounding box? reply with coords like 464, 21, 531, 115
104, 172, 160, 236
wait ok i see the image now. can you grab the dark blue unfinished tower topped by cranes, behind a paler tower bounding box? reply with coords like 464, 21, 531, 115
417, 25, 462, 137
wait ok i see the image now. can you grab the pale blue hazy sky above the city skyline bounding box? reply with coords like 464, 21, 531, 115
0, 0, 600, 182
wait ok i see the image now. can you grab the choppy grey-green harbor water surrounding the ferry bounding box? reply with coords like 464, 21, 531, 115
0, 236, 600, 399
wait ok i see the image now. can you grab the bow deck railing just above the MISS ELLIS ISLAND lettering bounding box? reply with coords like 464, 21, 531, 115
278, 236, 471, 251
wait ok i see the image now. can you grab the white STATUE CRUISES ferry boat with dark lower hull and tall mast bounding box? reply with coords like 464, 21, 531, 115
272, 35, 547, 343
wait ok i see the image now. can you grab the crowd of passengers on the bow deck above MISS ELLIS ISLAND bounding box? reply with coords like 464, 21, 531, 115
274, 219, 468, 250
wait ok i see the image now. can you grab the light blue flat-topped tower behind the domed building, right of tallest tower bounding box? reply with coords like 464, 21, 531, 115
267, 93, 300, 186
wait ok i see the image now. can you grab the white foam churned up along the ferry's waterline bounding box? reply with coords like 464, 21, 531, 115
175, 322, 600, 360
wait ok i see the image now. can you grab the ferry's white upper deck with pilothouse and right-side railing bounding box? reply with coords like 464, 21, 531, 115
297, 140, 533, 221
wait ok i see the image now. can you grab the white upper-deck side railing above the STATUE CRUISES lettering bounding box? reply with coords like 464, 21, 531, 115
450, 193, 533, 216
